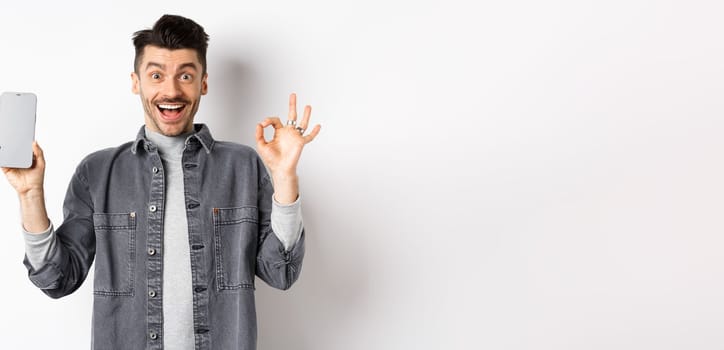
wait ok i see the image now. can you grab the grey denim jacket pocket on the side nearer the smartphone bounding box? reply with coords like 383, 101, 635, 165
93, 213, 136, 296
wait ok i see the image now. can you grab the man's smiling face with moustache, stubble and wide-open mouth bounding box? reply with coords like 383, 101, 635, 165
131, 46, 208, 136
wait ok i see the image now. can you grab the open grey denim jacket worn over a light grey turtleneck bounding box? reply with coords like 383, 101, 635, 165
25, 124, 305, 350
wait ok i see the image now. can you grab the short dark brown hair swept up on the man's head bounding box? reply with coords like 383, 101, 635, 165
133, 15, 209, 74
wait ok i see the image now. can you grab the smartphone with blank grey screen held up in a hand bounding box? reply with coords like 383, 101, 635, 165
0, 92, 38, 168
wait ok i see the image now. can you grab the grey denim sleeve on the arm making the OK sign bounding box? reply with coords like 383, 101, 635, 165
256, 166, 305, 290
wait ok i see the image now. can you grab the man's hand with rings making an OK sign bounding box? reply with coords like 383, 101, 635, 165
256, 94, 321, 204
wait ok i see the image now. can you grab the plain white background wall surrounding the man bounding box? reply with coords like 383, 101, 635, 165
0, 0, 724, 350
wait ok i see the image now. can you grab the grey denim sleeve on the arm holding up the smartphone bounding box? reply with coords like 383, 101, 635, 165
24, 167, 96, 298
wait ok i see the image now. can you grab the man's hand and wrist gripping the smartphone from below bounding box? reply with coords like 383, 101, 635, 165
2, 142, 50, 233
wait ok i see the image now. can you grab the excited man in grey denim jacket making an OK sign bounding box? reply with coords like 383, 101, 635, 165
3, 15, 320, 349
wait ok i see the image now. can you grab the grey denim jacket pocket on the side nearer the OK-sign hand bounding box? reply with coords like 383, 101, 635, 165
214, 207, 259, 291
